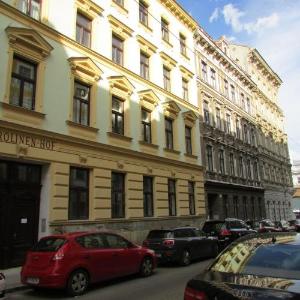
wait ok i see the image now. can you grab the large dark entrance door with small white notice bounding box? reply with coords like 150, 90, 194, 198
0, 161, 41, 268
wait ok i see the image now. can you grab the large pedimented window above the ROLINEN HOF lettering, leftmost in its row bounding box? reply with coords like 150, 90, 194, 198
10, 56, 37, 110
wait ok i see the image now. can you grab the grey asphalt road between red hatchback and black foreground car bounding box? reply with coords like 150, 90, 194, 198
7, 260, 211, 300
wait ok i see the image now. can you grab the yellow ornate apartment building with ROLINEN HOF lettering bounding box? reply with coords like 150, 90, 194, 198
0, 0, 205, 268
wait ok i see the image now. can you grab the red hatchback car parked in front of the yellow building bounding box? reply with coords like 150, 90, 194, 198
21, 232, 156, 296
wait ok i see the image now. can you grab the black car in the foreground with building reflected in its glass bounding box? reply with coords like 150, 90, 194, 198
184, 232, 300, 300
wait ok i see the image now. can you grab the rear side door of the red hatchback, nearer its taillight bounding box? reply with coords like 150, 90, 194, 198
76, 234, 115, 282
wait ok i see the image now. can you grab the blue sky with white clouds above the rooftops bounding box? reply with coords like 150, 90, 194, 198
177, 0, 300, 160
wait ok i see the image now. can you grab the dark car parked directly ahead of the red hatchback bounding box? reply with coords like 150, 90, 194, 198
143, 227, 219, 266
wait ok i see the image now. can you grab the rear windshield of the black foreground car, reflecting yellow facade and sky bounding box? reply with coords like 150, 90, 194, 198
211, 235, 300, 279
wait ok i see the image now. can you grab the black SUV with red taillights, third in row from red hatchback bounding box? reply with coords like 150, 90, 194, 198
202, 218, 256, 249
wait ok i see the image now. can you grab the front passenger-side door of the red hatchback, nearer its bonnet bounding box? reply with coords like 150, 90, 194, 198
105, 234, 141, 276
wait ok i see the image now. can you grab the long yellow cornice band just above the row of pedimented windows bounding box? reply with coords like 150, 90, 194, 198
0, 0, 198, 112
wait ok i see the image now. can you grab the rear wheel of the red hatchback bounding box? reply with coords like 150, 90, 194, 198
67, 270, 89, 296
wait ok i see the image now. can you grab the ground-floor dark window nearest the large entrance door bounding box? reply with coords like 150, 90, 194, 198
69, 167, 89, 220
